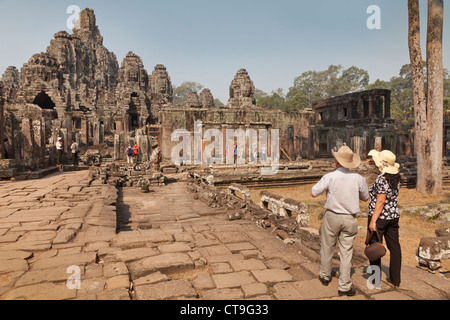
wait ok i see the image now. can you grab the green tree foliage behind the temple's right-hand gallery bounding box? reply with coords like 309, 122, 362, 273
255, 61, 450, 124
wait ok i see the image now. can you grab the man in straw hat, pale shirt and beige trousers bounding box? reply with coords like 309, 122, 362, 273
312, 146, 369, 296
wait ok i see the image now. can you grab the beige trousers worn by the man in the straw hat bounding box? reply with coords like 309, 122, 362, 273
320, 210, 358, 292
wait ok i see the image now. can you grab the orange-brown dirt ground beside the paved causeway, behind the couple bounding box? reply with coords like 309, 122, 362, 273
251, 184, 450, 267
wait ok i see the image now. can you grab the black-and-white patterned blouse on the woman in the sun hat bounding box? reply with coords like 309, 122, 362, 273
369, 175, 400, 220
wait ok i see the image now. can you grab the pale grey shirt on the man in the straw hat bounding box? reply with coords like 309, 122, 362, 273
312, 168, 369, 215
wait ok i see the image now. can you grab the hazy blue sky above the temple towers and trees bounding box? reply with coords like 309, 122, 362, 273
0, 0, 450, 103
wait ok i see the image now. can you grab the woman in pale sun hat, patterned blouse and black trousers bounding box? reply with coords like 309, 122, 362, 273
369, 150, 402, 287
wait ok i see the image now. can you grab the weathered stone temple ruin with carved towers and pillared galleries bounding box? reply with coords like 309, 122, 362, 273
0, 9, 449, 185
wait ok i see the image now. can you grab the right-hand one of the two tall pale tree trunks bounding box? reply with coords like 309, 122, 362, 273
425, 0, 444, 194
